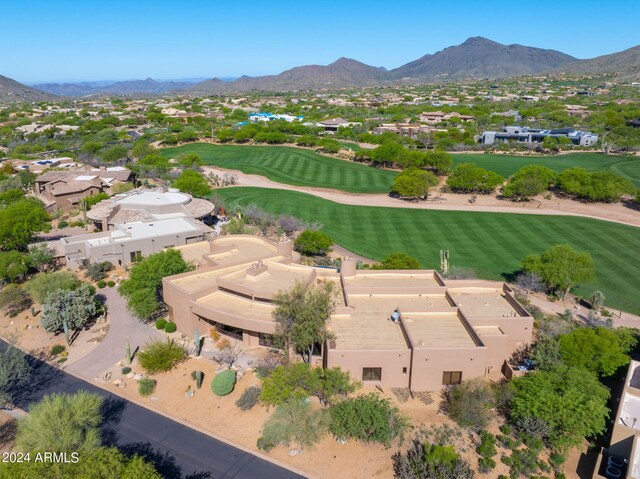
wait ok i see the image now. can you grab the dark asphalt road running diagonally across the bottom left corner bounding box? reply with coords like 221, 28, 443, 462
0, 341, 302, 479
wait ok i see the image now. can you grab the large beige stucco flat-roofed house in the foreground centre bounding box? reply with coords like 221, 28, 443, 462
163, 236, 533, 391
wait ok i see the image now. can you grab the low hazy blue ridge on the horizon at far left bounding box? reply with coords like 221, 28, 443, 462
34, 78, 193, 97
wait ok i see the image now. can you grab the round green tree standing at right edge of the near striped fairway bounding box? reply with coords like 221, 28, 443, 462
522, 244, 595, 300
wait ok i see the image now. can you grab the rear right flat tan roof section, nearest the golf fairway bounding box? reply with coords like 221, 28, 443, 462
448, 287, 521, 318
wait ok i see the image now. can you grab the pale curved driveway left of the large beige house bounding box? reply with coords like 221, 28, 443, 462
65, 287, 162, 380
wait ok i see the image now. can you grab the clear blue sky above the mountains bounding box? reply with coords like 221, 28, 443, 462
5, 0, 640, 82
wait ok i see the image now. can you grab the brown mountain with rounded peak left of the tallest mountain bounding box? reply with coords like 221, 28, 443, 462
189, 58, 388, 93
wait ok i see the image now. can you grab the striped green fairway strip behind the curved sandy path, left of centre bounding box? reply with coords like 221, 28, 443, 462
160, 143, 396, 193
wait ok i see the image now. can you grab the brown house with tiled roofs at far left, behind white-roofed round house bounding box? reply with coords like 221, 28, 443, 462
35, 166, 133, 210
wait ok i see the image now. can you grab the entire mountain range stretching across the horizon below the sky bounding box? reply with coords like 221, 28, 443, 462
0, 37, 640, 101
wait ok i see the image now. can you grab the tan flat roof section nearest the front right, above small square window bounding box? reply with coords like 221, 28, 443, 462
402, 313, 477, 348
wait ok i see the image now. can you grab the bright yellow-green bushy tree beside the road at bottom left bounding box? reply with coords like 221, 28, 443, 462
15, 391, 102, 452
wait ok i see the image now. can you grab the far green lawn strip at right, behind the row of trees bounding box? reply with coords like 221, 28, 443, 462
453, 153, 640, 186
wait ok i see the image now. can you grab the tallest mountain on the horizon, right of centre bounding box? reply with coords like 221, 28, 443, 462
391, 37, 576, 81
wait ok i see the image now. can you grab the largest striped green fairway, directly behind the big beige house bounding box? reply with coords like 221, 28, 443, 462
216, 187, 640, 313
